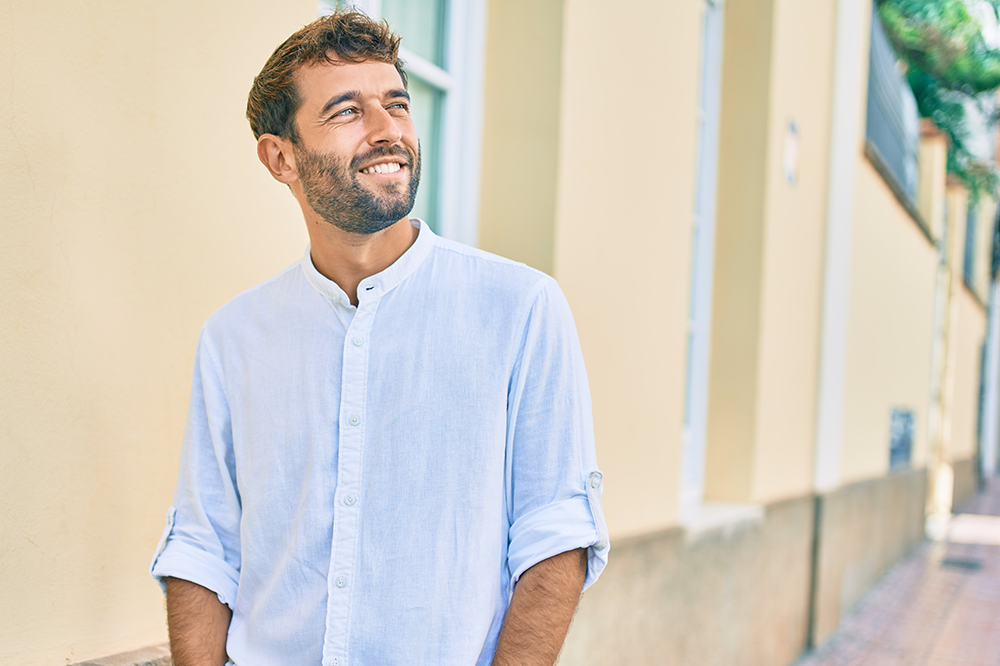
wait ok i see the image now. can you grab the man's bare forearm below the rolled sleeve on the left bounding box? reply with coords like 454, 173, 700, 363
166, 578, 233, 666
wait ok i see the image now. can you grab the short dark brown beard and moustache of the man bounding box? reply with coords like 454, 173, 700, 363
295, 144, 420, 236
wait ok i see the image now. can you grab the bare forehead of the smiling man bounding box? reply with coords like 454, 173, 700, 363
295, 60, 403, 109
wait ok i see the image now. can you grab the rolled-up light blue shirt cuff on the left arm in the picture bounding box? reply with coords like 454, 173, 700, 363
149, 507, 240, 609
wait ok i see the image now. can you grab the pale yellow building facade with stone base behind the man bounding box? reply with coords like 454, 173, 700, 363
0, 0, 997, 666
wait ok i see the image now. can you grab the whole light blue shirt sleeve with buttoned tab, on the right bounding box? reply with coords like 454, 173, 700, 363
505, 279, 610, 589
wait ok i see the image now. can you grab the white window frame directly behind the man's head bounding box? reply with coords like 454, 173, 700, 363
319, 0, 486, 245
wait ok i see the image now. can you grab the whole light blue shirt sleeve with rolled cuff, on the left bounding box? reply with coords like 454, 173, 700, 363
149, 331, 241, 608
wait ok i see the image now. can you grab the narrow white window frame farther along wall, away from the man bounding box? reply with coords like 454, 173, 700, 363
680, 0, 725, 522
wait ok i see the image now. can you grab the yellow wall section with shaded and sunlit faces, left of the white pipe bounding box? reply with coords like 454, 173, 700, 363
706, 0, 835, 502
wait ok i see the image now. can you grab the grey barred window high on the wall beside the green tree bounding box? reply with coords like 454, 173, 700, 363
865, 8, 920, 203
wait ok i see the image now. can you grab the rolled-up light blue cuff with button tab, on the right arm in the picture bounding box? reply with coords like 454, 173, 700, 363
507, 472, 610, 593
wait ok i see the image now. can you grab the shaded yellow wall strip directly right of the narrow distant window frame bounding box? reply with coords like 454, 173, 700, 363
705, 0, 779, 500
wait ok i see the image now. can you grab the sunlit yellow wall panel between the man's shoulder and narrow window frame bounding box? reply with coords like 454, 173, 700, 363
555, 0, 701, 536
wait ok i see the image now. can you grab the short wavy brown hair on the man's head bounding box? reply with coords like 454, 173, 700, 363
247, 12, 406, 143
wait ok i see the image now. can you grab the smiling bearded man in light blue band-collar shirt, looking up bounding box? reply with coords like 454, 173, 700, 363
151, 13, 608, 666
